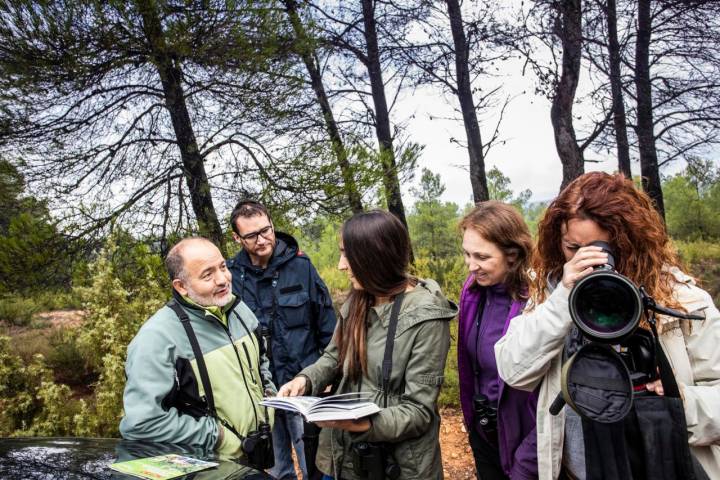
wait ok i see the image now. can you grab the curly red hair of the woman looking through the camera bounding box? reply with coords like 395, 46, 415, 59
531, 172, 680, 316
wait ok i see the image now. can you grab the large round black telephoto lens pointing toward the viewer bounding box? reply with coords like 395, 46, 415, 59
569, 242, 643, 343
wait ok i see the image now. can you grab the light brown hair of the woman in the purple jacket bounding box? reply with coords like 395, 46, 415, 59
460, 200, 533, 300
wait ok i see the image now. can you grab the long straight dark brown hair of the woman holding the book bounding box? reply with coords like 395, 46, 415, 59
335, 210, 410, 380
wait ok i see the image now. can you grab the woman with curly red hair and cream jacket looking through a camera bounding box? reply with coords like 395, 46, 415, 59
495, 172, 720, 479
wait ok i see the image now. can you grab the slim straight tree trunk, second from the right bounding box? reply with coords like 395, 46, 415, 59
606, 0, 632, 178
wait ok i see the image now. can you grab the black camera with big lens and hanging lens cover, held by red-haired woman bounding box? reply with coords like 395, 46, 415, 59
550, 241, 704, 423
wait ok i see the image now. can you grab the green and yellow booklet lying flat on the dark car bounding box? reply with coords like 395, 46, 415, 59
110, 454, 218, 480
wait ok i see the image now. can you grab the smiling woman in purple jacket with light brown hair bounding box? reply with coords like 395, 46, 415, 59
458, 201, 537, 480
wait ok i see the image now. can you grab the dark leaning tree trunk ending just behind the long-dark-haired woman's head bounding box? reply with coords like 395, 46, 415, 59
362, 0, 407, 233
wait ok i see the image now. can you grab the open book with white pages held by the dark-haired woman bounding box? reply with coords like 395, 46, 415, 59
260, 392, 380, 422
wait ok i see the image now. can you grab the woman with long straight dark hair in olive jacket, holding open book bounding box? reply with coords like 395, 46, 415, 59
278, 210, 457, 480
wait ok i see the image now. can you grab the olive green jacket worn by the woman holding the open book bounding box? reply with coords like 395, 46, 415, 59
300, 280, 457, 480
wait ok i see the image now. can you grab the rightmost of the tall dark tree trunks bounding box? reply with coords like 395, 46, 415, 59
635, 0, 665, 219
